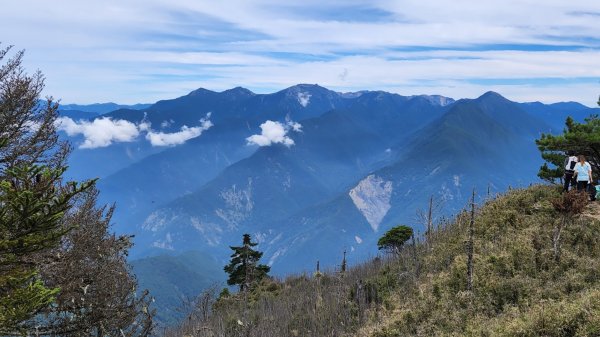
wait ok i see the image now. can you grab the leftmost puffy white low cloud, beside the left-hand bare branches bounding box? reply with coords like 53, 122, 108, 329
56, 117, 144, 149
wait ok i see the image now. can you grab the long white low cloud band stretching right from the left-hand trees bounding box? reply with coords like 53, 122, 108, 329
56, 114, 213, 149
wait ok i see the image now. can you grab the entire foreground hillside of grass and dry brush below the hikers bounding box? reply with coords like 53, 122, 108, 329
168, 186, 600, 337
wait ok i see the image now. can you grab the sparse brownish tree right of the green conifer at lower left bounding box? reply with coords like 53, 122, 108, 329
36, 189, 154, 337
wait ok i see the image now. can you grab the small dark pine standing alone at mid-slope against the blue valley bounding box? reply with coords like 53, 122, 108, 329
223, 234, 271, 291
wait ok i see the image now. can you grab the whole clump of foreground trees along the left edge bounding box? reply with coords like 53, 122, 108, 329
0, 47, 153, 337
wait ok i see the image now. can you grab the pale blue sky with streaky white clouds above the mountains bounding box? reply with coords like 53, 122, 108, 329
0, 0, 600, 106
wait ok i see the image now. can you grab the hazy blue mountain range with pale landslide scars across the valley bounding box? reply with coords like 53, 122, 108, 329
61, 84, 599, 322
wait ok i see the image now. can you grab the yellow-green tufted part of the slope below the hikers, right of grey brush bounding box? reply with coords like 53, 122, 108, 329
357, 186, 600, 337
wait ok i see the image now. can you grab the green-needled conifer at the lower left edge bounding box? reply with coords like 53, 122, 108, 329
0, 166, 92, 332
